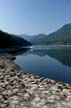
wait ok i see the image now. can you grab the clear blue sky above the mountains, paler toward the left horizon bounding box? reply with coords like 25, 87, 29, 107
0, 0, 71, 35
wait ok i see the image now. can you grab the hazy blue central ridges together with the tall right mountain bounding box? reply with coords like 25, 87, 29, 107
25, 23, 71, 45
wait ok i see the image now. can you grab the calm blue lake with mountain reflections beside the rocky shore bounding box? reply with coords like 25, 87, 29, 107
15, 46, 71, 83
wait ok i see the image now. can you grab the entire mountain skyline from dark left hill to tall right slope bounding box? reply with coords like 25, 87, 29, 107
0, 23, 71, 49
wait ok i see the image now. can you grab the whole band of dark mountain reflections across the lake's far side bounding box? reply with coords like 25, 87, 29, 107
14, 48, 71, 67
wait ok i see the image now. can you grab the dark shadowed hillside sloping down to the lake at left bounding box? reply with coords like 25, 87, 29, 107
0, 30, 31, 49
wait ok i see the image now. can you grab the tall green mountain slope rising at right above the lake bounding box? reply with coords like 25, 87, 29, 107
40, 24, 71, 44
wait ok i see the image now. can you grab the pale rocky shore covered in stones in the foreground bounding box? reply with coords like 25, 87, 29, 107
0, 58, 71, 108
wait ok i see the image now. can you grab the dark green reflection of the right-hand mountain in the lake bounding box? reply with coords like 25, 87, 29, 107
28, 49, 71, 67
